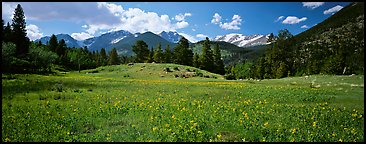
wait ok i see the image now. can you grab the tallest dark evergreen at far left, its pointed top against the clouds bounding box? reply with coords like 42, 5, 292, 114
11, 4, 29, 57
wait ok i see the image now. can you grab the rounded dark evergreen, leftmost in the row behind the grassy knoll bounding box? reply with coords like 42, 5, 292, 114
132, 40, 149, 62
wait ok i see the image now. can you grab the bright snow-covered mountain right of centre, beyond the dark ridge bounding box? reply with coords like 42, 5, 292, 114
213, 33, 269, 47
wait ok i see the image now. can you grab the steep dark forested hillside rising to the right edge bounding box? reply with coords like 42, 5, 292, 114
227, 2, 364, 79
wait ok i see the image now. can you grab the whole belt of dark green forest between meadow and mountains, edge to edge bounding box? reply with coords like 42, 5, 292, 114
2, 3, 364, 79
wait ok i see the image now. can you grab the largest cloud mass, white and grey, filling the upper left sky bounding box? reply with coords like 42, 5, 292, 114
2, 2, 192, 39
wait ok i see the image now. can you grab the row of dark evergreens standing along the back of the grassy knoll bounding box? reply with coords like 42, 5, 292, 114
132, 37, 225, 75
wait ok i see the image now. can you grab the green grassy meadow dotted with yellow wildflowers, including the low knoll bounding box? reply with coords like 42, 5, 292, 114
2, 64, 364, 142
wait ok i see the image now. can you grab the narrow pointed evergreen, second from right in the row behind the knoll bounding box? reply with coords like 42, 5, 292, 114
199, 37, 214, 72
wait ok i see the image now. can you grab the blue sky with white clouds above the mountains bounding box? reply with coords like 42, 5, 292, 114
2, 2, 350, 42
